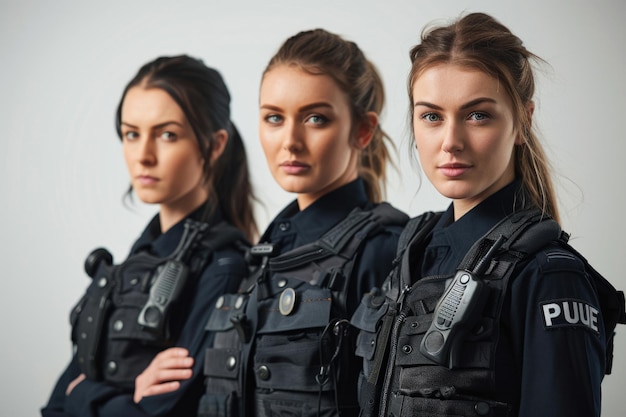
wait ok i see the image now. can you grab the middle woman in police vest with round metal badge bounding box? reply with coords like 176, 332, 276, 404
139, 29, 408, 417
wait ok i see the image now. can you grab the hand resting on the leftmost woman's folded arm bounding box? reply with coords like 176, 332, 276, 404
133, 348, 193, 403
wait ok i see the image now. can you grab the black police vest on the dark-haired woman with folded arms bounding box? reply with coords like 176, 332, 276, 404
70, 219, 245, 389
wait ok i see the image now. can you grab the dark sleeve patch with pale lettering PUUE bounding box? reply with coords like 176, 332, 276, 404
541, 298, 600, 335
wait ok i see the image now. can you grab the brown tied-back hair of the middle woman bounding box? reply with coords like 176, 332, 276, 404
264, 29, 393, 202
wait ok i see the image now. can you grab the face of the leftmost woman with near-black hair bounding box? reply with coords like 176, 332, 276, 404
121, 86, 208, 214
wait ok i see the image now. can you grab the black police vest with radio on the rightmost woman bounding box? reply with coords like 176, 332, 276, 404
352, 210, 626, 417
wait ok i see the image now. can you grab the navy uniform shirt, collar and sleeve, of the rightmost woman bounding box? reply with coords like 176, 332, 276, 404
422, 181, 605, 417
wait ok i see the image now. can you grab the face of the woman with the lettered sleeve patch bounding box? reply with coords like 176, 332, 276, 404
413, 64, 520, 219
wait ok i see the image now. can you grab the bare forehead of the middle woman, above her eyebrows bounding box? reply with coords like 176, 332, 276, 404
260, 65, 349, 106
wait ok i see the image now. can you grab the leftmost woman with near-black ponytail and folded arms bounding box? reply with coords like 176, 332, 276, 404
42, 56, 257, 417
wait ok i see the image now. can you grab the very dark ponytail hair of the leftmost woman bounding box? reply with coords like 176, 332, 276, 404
115, 55, 258, 240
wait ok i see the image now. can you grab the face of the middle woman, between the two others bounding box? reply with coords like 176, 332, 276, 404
259, 65, 362, 210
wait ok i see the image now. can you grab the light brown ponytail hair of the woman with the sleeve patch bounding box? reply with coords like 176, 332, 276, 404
408, 13, 559, 221
